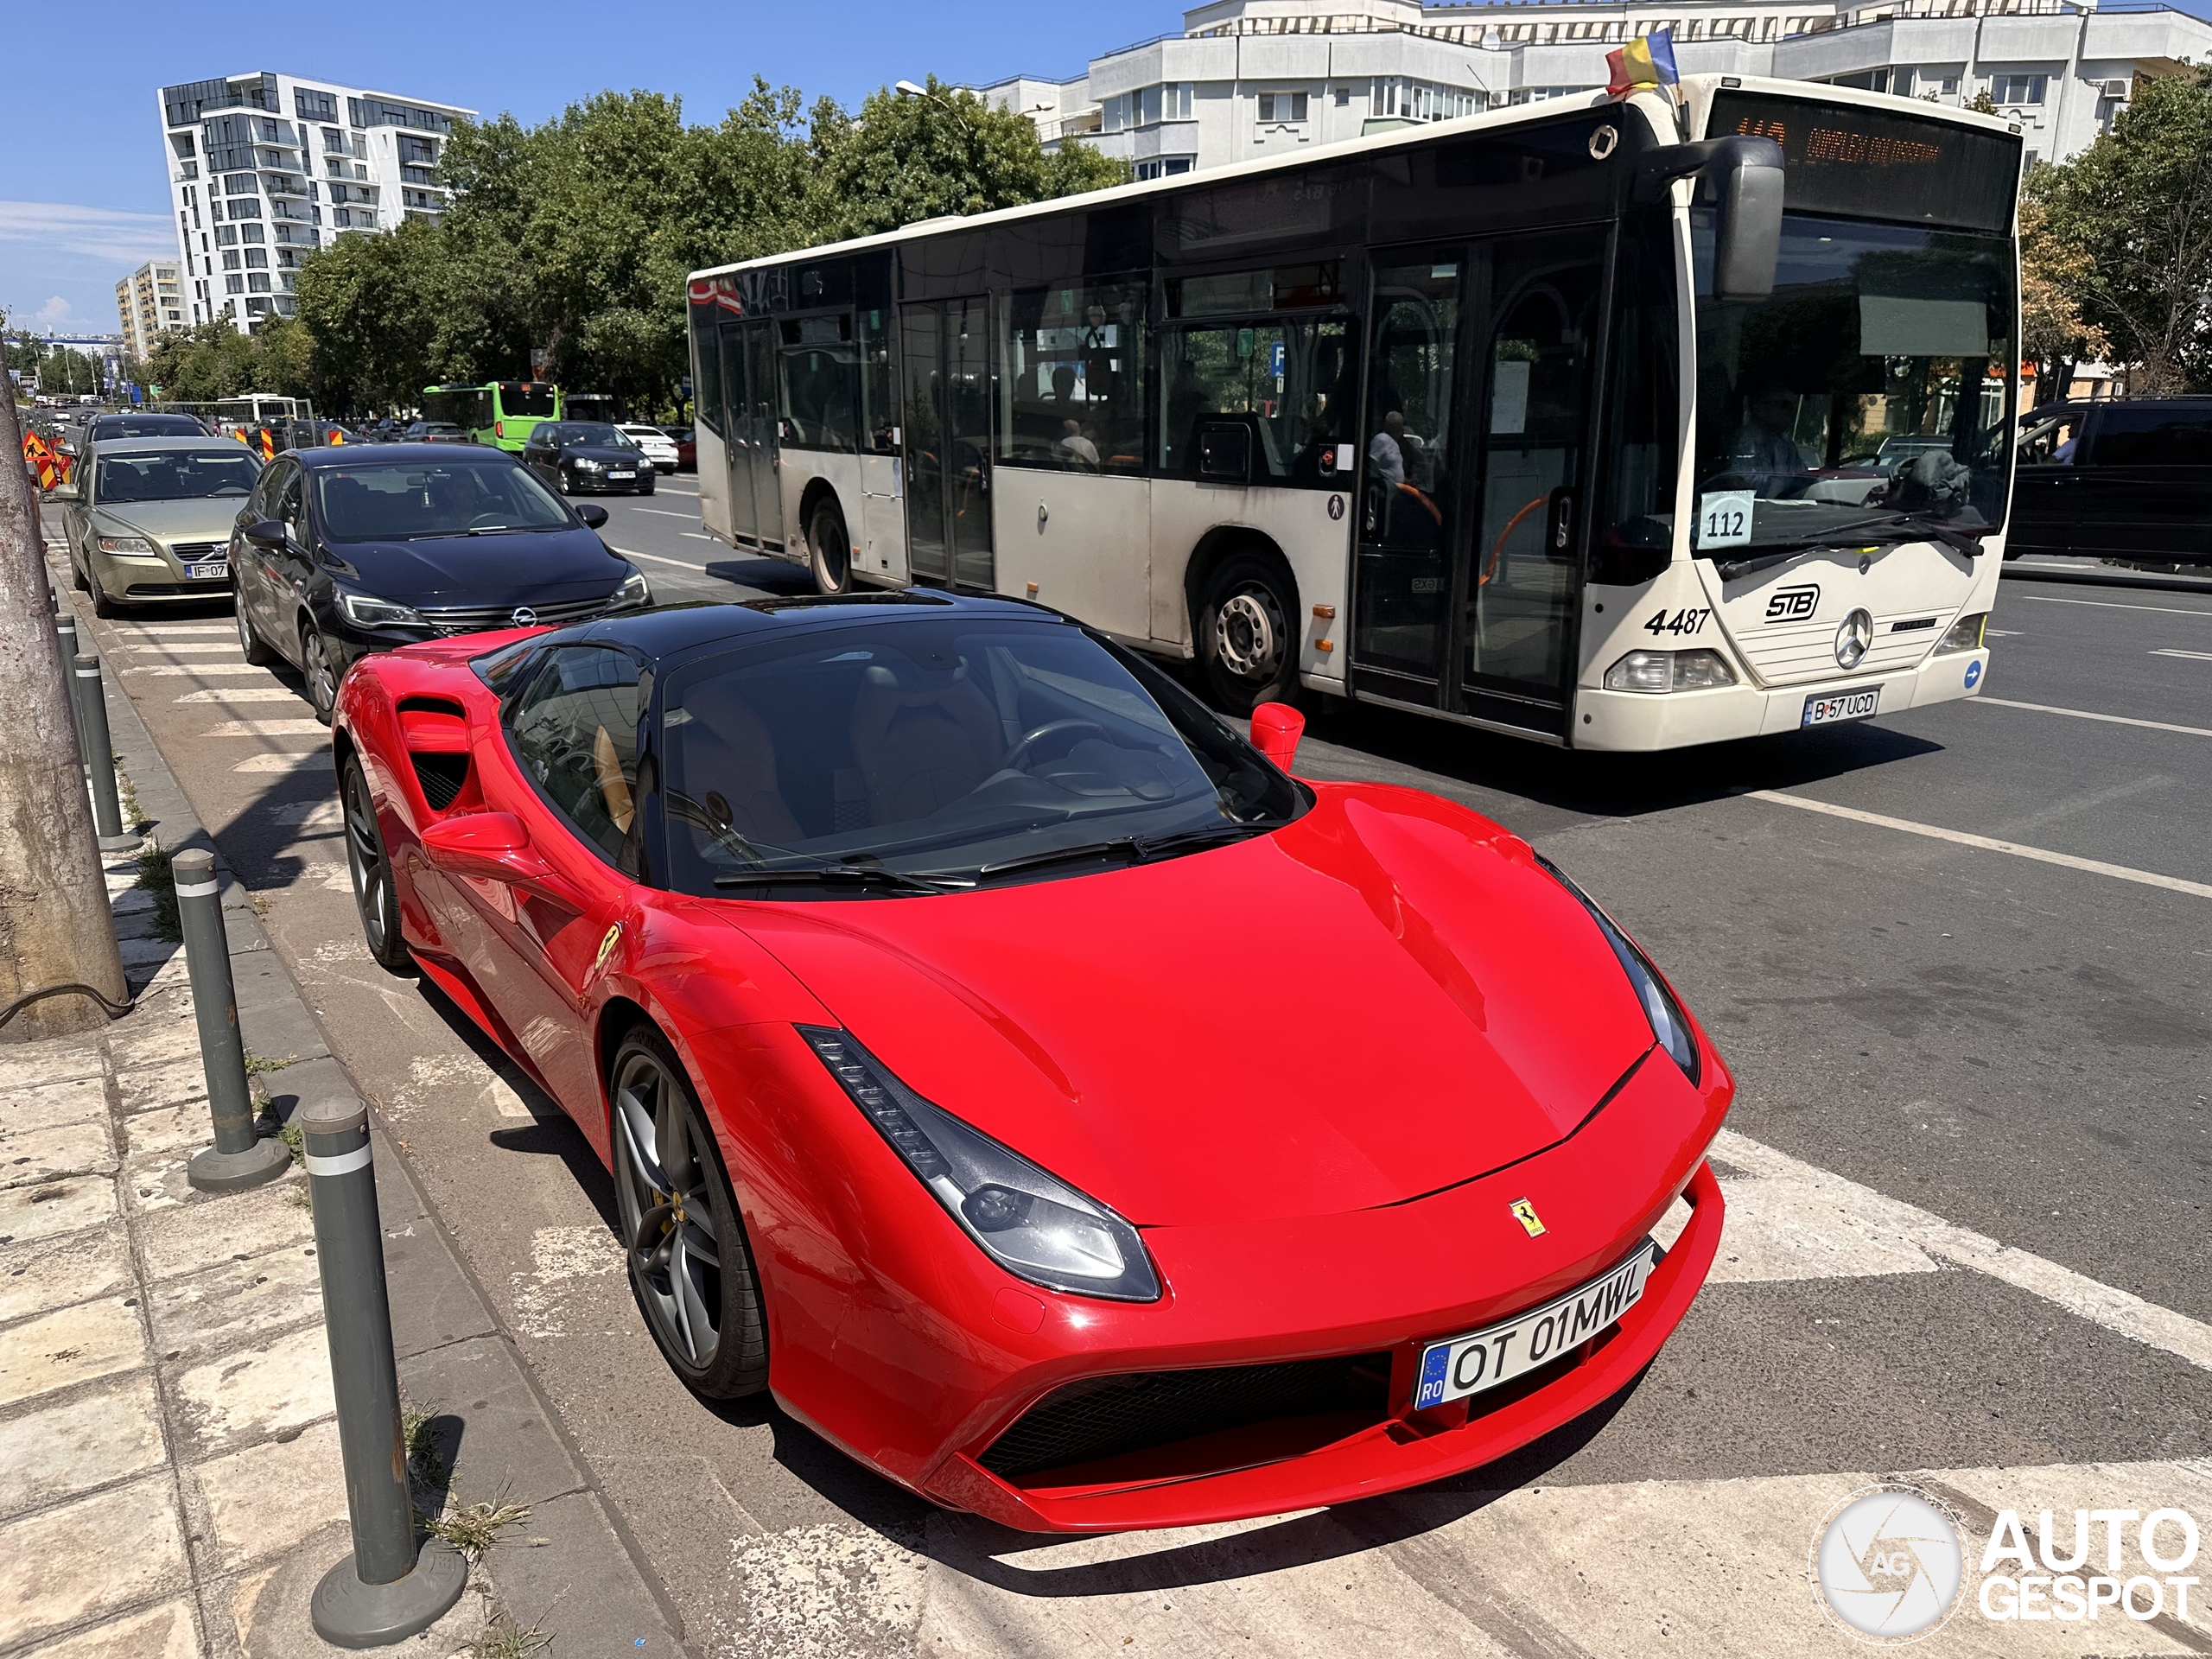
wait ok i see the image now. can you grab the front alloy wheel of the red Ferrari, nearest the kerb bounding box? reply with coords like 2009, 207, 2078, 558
608, 1027, 767, 1400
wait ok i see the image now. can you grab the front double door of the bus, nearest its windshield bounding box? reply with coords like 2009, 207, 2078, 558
1354, 226, 1608, 736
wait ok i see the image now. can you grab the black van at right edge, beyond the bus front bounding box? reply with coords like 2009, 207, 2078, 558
2004, 398, 2212, 564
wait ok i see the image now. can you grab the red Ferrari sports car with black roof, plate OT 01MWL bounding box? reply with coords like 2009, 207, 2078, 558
334, 593, 1734, 1531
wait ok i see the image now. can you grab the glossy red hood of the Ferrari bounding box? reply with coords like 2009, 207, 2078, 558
715, 785, 1652, 1225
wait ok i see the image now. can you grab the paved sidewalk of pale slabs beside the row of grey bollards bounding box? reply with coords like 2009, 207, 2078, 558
0, 570, 683, 1659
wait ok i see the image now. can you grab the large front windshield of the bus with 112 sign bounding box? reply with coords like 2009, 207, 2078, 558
1692, 213, 2013, 557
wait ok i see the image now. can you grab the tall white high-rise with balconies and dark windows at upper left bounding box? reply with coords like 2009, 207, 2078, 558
159, 71, 475, 329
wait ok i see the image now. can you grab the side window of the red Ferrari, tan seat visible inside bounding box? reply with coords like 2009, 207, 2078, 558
509, 646, 639, 874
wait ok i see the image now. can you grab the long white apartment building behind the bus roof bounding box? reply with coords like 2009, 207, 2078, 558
978, 0, 2212, 179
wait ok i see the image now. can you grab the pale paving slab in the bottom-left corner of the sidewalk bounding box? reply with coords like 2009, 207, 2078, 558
0, 1471, 190, 1652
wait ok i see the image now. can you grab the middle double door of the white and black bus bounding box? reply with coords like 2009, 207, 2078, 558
898, 294, 993, 593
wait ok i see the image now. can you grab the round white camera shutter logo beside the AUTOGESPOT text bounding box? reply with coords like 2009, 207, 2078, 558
1812, 1482, 1967, 1646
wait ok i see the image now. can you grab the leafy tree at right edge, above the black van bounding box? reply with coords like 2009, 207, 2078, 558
2039, 67, 2212, 394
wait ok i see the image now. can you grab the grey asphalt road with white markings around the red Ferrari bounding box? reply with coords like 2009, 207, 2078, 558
48, 498, 2212, 1659
